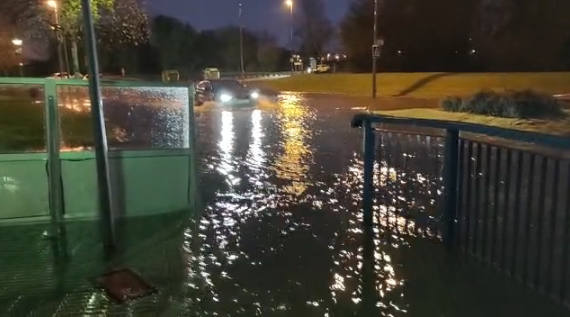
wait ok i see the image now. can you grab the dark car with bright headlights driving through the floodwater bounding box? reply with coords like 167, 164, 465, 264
195, 79, 259, 106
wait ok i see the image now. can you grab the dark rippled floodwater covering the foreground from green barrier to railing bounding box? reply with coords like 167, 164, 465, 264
0, 93, 567, 316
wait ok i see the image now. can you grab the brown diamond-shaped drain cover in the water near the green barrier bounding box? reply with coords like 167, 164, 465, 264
97, 269, 156, 303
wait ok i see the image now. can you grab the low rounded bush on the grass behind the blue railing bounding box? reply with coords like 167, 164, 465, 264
441, 90, 564, 118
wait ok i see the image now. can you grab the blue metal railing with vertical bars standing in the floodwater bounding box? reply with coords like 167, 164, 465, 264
352, 114, 570, 305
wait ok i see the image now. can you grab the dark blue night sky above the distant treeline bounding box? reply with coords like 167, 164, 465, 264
146, 0, 351, 44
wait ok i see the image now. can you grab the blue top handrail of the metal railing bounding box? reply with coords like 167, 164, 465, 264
351, 113, 570, 150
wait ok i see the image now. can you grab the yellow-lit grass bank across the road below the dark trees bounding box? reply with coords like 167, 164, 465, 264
254, 72, 570, 99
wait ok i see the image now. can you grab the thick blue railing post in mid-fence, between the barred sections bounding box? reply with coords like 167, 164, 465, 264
443, 129, 461, 249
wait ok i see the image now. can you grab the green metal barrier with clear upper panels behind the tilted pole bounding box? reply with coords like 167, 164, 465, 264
0, 78, 196, 225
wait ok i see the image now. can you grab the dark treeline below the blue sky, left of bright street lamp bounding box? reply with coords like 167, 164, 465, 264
100, 16, 290, 78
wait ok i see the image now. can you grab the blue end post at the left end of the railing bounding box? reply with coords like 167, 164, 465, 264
362, 120, 375, 227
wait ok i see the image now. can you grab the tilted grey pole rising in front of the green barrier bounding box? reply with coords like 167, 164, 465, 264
81, 0, 116, 251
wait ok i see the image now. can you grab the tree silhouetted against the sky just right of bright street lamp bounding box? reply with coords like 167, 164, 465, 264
295, 0, 334, 57
